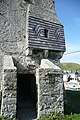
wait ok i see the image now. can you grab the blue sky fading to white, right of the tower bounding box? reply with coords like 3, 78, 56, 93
55, 0, 80, 64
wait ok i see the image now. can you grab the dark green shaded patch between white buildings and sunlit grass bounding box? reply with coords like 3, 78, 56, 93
64, 90, 80, 115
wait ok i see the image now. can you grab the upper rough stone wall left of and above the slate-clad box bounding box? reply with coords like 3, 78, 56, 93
0, 0, 65, 57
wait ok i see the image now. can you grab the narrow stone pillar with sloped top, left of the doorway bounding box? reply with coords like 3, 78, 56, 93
1, 56, 17, 119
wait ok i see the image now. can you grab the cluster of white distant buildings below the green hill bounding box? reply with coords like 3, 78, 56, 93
63, 71, 80, 91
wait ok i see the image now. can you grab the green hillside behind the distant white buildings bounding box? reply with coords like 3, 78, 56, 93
60, 63, 80, 73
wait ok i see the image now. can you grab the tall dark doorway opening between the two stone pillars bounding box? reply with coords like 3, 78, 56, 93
17, 74, 37, 120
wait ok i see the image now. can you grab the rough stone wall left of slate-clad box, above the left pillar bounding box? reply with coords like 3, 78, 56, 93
0, 0, 27, 55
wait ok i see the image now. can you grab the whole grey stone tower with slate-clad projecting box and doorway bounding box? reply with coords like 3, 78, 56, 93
0, 0, 65, 120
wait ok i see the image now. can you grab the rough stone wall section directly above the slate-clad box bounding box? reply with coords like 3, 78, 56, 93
29, 0, 61, 24
